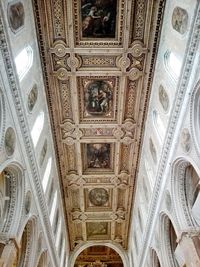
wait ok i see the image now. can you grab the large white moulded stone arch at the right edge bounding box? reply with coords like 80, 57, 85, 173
171, 158, 200, 229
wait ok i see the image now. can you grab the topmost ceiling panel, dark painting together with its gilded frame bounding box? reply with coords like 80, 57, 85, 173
74, 0, 124, 46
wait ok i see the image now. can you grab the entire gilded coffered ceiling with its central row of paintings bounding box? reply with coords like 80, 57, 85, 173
33, 0, 164, 253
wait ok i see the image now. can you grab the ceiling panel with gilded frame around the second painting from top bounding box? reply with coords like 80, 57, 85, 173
78, 77, 119, 123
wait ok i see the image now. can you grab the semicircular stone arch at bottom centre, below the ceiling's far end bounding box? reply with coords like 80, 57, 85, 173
68, 241, 130, 267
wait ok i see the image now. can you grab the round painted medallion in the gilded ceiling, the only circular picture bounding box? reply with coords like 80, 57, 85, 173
89, 188, 109, 206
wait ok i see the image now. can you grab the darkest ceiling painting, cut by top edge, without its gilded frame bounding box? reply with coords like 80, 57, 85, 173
81, 0, 117, 38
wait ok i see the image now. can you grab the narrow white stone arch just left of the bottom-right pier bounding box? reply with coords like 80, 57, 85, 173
160, 212, 178, 267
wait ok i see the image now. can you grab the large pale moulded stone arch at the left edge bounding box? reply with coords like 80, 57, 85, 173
0, 163, 24, 235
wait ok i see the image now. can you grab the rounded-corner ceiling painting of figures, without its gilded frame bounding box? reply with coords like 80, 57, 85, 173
85, 81, 112, 115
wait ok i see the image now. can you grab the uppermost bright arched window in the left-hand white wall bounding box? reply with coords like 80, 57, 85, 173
15, 45, 33, 81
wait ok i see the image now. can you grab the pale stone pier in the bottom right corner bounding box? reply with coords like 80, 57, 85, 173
178, 229, 200, 267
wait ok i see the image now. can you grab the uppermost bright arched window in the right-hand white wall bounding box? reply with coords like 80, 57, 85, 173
164, 50, 181, 80
